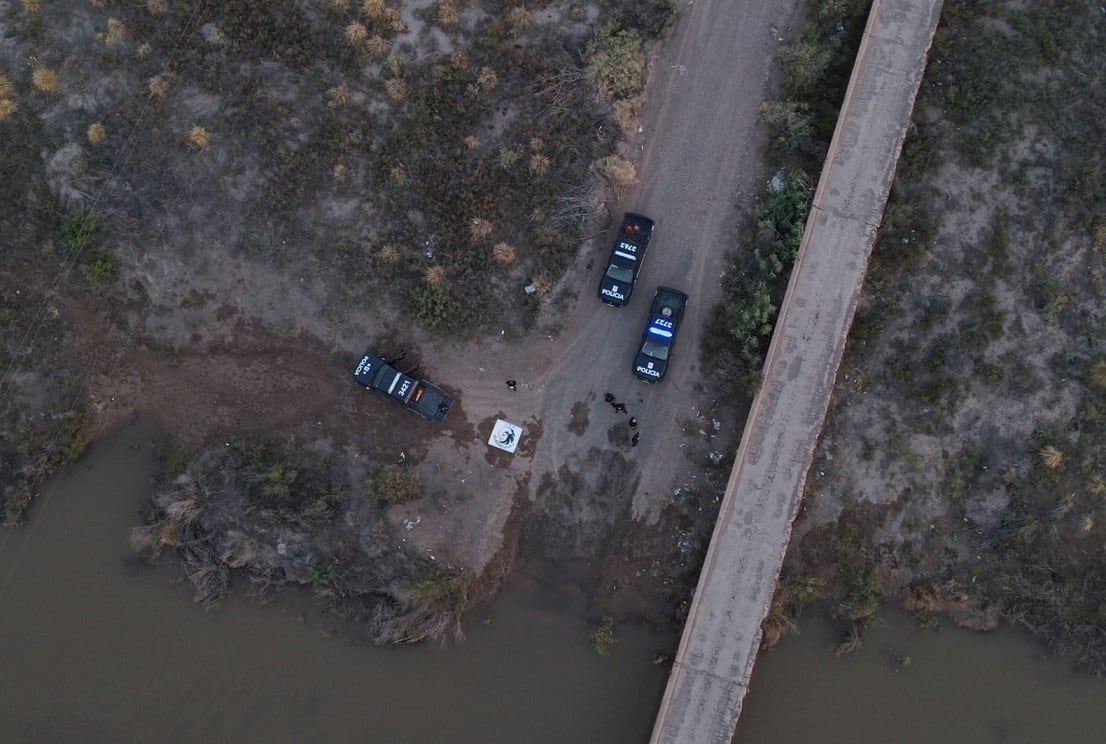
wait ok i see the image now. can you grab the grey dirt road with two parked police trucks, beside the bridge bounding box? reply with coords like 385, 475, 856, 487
407, 0, 801, 566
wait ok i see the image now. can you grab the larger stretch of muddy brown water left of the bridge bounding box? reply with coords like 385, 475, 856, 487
0, 423, 674, 744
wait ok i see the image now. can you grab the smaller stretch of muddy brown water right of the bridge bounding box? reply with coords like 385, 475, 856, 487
733, 611, 1106, 744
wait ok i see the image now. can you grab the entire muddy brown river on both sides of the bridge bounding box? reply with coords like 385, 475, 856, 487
0, 425, 1106, 744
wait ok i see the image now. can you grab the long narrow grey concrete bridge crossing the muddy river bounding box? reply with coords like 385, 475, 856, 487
651, 0, 941, 744
